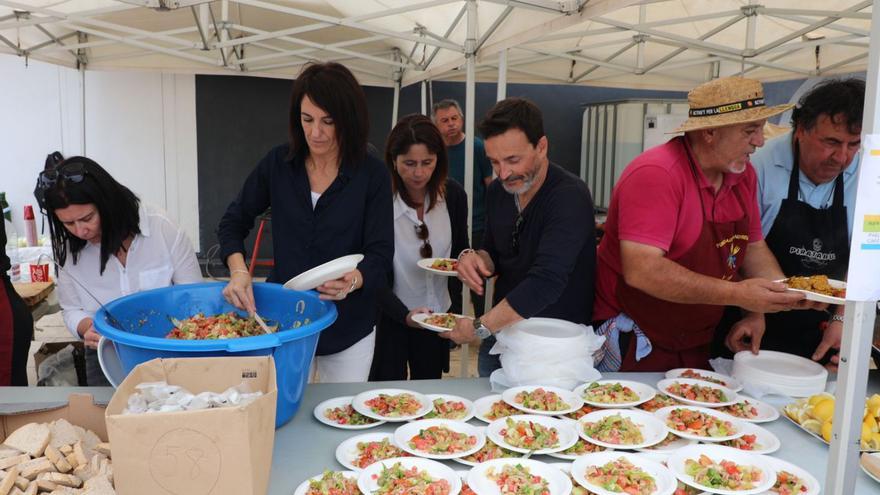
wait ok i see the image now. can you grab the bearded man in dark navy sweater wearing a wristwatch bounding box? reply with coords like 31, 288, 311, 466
441, 98, 596, 376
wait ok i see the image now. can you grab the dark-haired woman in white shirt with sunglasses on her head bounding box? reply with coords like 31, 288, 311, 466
34, 156, 202, 386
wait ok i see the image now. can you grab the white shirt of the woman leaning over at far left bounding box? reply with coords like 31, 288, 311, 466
58, 203, 203, 338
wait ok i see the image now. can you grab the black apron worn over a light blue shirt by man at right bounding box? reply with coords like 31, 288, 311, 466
761, 145, 849, 362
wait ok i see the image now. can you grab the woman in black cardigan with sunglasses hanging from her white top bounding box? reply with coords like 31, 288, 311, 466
370, 115, 468, 381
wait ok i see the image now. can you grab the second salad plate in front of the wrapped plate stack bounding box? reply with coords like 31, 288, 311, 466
486, 414, 578, 454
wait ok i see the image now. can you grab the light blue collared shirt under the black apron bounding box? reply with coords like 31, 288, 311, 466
751, 132, 859, 237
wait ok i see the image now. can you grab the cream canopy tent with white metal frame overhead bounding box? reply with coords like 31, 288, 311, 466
0, 0, 880, 495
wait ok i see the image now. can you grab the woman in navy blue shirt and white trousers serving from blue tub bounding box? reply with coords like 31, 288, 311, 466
218, 62, 394, 382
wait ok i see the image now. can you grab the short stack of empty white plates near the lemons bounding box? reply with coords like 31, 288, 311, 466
733, 350, 828, 397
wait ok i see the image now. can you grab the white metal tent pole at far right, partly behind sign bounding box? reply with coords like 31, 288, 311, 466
825, 0, 880, 495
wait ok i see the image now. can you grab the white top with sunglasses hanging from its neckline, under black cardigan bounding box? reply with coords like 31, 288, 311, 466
393, 194, 452, 312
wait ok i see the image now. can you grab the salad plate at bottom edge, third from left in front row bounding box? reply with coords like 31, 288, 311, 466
467, 459, 572, 495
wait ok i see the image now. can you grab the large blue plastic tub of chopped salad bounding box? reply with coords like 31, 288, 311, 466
95, 283, 336, 428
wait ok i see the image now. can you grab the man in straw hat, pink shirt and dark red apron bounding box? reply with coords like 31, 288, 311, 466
593, 77, 820, 371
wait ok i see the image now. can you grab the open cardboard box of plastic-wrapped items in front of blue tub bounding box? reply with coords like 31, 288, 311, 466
106, 356, 278, 495
